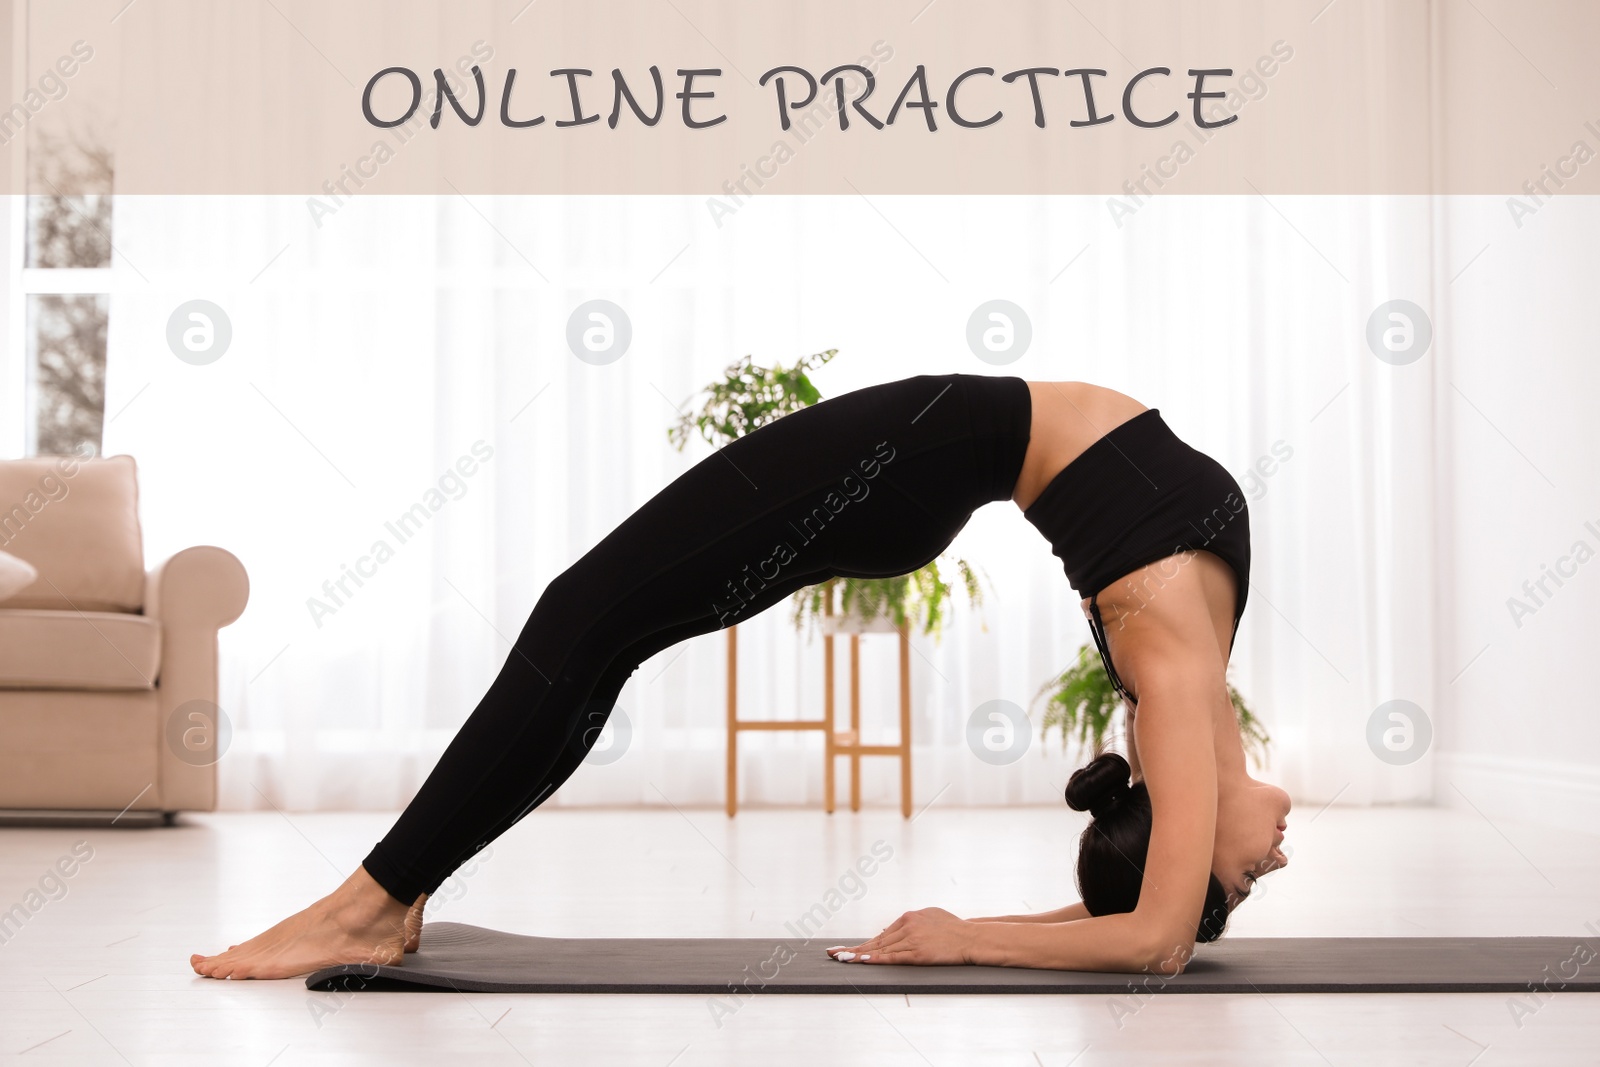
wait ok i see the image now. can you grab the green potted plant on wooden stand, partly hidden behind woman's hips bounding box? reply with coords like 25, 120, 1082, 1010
667, 349, 982, 633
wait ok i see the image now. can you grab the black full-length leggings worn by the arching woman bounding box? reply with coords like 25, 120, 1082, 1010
362, 374, 1032, 904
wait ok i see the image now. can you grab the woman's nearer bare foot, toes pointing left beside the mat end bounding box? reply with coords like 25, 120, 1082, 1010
189, 867, 421, 977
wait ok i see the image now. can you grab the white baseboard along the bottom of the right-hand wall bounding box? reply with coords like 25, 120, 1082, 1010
1434, 752, 1600, 833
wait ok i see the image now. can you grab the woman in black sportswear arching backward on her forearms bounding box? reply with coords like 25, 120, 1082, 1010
190, 374, 1290, 977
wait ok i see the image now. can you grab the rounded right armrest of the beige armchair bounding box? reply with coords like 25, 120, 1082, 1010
141, 545, 250, 811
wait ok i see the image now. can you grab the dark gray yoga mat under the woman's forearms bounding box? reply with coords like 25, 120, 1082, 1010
306, 923, 1600, 997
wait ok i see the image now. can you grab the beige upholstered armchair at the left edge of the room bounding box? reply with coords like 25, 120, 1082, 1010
0, 456, 250, 816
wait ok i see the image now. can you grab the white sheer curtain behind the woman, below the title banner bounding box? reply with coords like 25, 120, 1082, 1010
106, 195, 1437, 809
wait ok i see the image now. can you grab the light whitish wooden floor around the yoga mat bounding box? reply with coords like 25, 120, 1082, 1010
0, 806, 1600, 1067
